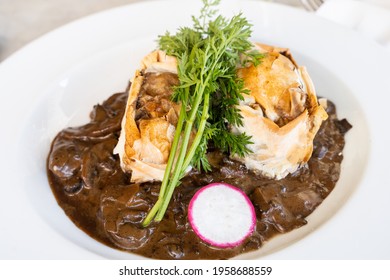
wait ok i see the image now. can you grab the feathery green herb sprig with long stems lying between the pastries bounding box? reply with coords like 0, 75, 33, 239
143, 0, 261, 226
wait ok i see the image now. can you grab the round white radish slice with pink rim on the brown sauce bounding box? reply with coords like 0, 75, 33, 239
188, 183, 256, 248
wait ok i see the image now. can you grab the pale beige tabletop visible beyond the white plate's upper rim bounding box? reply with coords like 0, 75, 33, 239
0, 0, 300, 62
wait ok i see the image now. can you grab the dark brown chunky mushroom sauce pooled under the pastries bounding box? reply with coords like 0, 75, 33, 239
47, 93, 351, 259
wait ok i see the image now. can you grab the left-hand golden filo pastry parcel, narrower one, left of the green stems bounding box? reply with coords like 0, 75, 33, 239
114, 51, 179, 182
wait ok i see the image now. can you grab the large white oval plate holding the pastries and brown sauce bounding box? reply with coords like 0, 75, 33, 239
0, 1, 390, 259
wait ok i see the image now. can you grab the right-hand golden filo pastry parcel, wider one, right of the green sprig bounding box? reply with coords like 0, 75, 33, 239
233, 44, 328, 179
